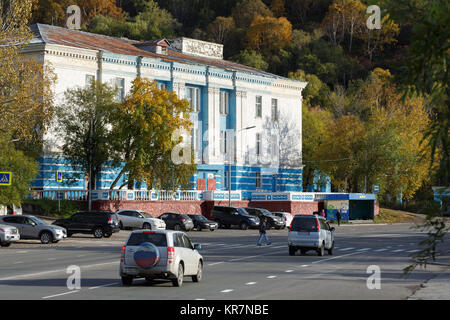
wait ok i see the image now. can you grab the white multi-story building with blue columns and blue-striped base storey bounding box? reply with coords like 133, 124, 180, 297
24, 24, 306, 198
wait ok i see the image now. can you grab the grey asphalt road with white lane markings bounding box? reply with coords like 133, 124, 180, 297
0, 224, 450, 300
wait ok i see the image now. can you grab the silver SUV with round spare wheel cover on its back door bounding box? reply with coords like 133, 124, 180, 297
119, 230, 203, 287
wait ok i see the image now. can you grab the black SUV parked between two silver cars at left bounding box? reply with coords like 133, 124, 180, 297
53, 211, 120, 238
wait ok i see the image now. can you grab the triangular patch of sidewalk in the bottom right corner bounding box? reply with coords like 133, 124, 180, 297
408, 267, 450, 300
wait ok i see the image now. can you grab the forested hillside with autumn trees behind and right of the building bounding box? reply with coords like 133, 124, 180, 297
29, 0, 450, 204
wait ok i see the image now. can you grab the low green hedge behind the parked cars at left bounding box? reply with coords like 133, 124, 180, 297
22, 199, 87, 218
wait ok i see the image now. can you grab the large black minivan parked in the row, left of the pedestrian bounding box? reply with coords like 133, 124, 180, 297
211, 206, 259, 230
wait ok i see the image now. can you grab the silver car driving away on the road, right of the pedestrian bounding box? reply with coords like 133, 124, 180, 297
288, 215, 334, 256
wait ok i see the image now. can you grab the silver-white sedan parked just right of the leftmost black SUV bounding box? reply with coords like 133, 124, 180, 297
116, 209, 166, 230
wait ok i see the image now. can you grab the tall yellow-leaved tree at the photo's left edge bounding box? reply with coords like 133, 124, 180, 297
0, 0, 55, 205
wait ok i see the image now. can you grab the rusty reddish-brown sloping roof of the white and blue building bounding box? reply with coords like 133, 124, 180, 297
30, 23, 298, 82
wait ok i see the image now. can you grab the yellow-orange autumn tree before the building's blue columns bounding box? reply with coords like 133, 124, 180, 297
110, 77, 196, 190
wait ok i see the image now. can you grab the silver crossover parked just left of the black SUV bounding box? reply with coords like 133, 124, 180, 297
0, 215, 67, 244
